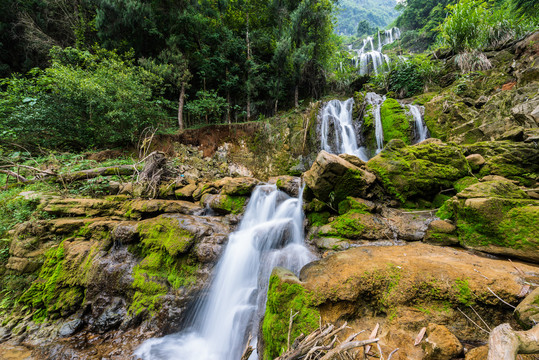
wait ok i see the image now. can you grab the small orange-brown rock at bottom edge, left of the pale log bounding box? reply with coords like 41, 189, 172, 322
423, 324, 463, 360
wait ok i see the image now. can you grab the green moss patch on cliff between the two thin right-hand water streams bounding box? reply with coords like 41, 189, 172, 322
380, 98, 411, 144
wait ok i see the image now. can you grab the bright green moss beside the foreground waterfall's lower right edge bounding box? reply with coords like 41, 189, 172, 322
262, 275, 320, 360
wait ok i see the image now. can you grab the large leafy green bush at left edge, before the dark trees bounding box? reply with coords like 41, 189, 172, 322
0, 48, 166, 149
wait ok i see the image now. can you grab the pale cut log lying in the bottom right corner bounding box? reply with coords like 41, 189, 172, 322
488, 324, 539, 360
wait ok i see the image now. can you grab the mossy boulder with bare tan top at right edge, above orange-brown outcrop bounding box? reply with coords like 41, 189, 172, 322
443, 180, 539, 262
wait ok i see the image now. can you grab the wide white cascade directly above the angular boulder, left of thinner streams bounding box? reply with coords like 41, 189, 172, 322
320, 98, 369, 161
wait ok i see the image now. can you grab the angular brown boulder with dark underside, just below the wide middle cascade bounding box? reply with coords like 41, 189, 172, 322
303, 150, 376, 204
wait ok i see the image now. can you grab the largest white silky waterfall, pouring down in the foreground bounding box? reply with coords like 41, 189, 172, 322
135, 185, 314, 360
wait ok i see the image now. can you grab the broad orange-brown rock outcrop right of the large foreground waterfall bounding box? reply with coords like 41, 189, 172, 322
299, 242, 539, 359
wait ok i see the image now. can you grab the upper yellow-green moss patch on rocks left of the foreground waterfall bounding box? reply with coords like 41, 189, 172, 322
138, 216, 194, 256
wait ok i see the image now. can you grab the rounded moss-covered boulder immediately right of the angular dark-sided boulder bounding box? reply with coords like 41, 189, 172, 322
367, 139, 470, 203
